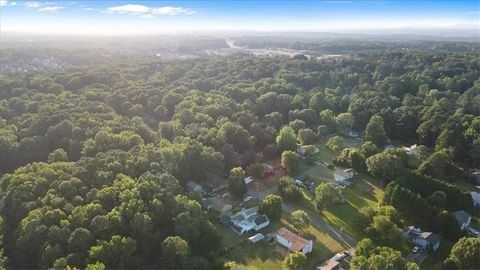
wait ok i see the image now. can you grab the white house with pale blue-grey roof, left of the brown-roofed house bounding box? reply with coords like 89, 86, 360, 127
230, 207, 270, 234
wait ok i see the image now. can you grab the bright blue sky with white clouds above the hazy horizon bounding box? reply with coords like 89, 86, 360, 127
0, 0, 480, 35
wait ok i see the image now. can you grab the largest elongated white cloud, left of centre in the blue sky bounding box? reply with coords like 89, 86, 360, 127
104, 4, 195, 18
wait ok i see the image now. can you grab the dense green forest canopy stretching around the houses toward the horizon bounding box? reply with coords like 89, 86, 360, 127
0, 38, 480, 269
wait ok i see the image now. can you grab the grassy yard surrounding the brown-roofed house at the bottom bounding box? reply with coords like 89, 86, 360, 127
217, 213, 346, 269
